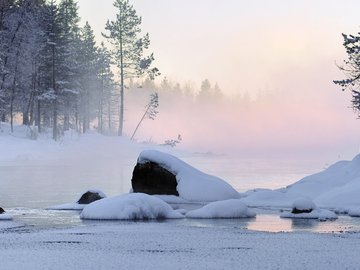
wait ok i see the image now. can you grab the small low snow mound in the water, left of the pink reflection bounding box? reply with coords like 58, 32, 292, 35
186, 199, 256, 218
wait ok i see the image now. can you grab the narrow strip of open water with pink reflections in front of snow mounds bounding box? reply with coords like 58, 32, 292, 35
2, 208, 360, 233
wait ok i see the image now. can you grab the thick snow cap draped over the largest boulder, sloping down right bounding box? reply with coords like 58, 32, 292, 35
138, 150, 240, 202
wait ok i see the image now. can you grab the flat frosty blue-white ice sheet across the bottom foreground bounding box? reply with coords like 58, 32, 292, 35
0, 222, 360, 270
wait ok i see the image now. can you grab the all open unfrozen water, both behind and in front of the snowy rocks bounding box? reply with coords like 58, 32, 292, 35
0, 155, 354, 232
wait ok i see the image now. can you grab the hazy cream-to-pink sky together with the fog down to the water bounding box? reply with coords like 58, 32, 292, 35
79, 0, 360, 160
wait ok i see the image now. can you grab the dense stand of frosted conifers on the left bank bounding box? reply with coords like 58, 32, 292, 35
0, 0, 118, 139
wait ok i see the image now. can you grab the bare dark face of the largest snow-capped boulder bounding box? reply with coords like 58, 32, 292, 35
131, 162, 179, 196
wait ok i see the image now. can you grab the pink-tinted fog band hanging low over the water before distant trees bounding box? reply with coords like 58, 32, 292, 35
125, 81, 360, 159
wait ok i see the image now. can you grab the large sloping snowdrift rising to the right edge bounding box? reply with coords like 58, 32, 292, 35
242, 155, 360, 209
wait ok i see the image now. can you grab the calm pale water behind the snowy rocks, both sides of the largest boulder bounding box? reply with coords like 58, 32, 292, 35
0, 155, 321, 208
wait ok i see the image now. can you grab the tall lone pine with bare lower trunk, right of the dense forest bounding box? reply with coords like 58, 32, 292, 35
103, 0, 159, 136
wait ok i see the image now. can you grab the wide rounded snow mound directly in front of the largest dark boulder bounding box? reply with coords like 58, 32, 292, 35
80, 193, 184, 220
